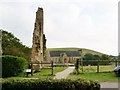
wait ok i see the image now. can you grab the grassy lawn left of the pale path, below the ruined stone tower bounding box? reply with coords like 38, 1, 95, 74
4, 67, 68, 79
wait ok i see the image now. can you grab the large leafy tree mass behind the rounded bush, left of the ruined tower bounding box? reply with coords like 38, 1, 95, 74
0, 30, 31, 60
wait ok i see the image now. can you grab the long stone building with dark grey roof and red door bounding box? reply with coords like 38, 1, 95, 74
47, 51, 81, 64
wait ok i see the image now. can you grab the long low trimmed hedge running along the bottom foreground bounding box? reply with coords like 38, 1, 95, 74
2, 79, 100, 90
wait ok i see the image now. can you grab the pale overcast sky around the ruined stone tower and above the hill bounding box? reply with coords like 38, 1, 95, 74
0, 0, 119, 55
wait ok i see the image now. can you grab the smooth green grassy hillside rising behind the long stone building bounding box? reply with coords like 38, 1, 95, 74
47, 48, 103, 56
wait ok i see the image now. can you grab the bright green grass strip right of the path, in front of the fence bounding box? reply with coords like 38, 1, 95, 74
68, 72, 120, 82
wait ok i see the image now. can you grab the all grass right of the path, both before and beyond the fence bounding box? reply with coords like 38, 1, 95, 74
68, 65, 120, 82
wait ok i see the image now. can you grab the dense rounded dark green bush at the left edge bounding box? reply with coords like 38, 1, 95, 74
0, 55, 28, 78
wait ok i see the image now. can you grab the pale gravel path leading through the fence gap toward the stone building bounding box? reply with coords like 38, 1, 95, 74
54, 66, 75, 79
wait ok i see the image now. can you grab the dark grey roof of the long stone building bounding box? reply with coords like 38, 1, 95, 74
49, 51, 80, 57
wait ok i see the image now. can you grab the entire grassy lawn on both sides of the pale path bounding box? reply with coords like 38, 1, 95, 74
2, 65, 120, 82
